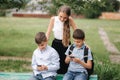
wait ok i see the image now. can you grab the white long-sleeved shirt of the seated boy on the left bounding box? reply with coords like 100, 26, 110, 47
31, 45, 60, 78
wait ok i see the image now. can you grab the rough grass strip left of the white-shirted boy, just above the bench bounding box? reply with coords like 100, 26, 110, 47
0, 59, 31, 72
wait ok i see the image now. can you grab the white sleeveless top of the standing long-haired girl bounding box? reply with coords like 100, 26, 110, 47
53, 16, 64, 40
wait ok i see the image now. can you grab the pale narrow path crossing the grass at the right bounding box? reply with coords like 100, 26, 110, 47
99, 28, 120, 63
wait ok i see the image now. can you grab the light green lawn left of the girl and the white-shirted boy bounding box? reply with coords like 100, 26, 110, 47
0, 18, 48, 57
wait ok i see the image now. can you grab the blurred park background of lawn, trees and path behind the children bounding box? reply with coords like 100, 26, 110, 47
0, 0, 120, 80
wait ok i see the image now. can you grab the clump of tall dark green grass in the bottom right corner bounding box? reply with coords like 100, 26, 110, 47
95, 59, 120, 80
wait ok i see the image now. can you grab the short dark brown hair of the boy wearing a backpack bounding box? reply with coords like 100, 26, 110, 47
73, 29, 85, 40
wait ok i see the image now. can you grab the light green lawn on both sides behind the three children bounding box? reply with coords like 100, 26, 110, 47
0, 17, 120, 59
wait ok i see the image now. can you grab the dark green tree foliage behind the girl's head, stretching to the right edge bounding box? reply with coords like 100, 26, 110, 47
47, 0, 120, 18
